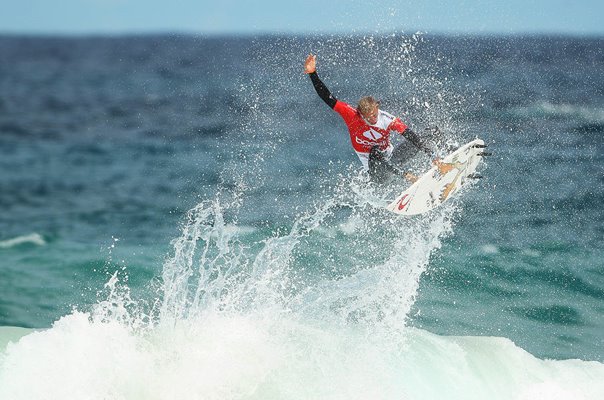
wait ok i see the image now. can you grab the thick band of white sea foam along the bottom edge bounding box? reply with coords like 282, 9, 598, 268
0, 313, 604, 400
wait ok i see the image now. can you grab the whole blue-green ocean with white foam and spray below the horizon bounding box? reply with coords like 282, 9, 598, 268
0, 33, 604, 400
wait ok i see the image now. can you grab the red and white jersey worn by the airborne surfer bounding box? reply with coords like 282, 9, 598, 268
333, 100, 407, 169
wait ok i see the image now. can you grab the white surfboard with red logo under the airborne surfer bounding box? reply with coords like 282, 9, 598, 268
386, 139, 486, 215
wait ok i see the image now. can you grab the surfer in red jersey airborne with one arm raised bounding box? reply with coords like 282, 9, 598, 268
304, 54, 446, 183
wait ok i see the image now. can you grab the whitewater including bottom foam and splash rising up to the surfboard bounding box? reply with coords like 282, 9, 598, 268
0, 187, 604, 400
